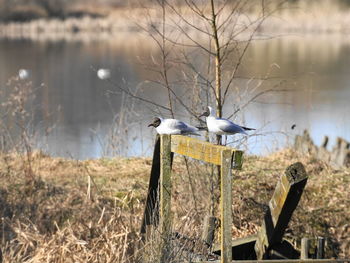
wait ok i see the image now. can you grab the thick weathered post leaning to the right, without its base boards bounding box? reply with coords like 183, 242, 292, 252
255, 162, 307, 259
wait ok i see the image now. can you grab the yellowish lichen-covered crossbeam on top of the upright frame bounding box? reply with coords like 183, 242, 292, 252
171, 135, 243, 169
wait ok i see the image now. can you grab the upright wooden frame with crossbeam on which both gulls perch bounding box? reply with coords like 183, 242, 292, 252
141, 135, 243, 263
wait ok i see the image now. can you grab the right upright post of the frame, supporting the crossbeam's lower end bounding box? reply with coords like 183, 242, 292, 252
220, 150, 232, 263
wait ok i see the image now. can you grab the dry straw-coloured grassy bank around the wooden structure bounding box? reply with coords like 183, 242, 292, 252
0, 150, 350, 262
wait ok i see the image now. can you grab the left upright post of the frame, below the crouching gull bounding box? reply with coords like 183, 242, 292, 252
159, 135, 171, 263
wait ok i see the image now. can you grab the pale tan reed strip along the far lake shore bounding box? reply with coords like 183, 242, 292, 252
0, 7, 350, 41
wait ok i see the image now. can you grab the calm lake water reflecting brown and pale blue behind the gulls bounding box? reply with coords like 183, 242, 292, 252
0, 35, 350, 159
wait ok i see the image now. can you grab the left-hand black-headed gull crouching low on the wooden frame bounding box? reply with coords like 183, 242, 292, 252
148, 117, 200, 135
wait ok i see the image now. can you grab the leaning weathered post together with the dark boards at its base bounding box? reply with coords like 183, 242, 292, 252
214, 163, 307, 260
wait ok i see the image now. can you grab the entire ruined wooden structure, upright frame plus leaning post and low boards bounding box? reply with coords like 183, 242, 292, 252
141, 135, 350, 263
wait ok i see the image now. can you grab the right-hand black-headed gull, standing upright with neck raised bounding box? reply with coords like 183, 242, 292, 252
200, 106, 255, 135
